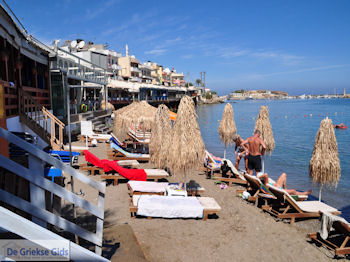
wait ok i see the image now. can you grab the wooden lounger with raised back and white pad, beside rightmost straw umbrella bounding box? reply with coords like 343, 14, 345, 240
262, 186, 341, 224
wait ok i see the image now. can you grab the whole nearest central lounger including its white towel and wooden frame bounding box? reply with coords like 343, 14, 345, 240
129, 195, 221, 220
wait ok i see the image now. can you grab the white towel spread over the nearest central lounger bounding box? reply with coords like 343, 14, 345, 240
134, 195, 203, 218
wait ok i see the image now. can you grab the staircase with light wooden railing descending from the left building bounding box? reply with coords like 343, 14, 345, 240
19, 88, 65, 150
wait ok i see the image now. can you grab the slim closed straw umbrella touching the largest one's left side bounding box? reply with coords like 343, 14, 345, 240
149, 104, 171, 168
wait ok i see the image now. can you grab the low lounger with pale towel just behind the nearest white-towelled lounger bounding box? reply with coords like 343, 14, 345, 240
127, 181, 205, 196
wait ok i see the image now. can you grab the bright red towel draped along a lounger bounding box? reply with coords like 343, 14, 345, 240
84, 150, 147, 181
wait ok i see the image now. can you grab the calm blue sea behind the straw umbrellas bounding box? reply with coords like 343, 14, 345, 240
197, 98, 350, 221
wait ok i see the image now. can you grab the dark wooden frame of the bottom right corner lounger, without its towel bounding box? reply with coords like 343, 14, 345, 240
308, 213, 350, 256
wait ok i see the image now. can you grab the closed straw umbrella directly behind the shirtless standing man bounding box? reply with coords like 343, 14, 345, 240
254, 106, 275, 172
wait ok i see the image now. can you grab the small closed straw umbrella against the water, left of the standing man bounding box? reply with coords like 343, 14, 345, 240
219, 104, 237, 158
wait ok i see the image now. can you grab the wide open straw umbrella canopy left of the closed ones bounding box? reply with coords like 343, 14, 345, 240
113, 101, 157, 139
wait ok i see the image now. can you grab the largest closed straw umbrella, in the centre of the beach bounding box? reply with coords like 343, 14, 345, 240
168, 96, 205, 188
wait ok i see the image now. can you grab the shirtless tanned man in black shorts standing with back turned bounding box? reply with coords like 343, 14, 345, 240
242, 130, 266, 175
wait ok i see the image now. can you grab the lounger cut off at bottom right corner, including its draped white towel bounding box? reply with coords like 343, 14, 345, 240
308, 213, 350, 256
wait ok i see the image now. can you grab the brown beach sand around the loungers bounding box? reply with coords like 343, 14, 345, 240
67, 143, 344, 262
